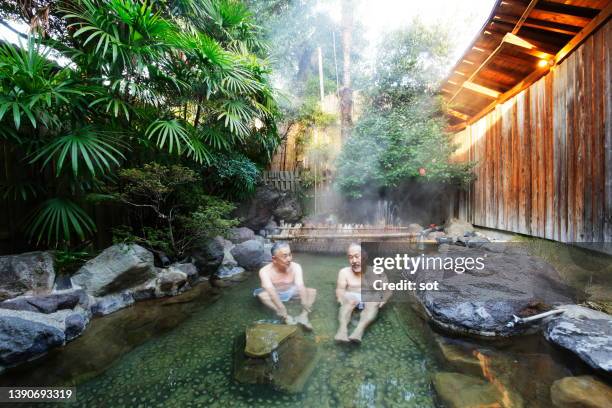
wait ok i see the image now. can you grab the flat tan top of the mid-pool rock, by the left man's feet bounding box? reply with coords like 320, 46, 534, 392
244, 323, 297, 358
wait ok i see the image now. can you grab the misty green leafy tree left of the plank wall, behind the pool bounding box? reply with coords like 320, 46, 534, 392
337, 21, 472, 198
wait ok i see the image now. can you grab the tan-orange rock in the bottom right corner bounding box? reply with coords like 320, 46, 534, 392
550, 375, 612, 408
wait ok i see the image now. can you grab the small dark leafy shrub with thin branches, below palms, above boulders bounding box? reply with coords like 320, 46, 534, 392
110, 163, 237, 258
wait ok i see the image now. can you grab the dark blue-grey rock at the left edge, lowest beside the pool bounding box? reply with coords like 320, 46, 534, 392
0, 308, 89, 367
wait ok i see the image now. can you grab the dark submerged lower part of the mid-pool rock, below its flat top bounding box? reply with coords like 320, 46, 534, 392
234, 326, 319, 393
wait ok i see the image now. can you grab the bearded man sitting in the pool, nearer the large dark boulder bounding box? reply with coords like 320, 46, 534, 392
334, 243, 387, 343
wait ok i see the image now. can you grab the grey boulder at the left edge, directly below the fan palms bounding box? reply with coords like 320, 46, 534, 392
0, 252, 55, 300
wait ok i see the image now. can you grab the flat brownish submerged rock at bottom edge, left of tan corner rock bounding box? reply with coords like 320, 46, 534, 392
433, 372, 523, 408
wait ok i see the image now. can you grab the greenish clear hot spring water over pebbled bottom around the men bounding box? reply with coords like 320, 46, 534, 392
0, 254, 592, 408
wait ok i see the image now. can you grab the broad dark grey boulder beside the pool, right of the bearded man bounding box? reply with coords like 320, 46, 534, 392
413, 245, 572, 337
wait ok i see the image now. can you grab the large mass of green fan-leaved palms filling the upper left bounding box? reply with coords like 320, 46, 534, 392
0, 0, 278, 247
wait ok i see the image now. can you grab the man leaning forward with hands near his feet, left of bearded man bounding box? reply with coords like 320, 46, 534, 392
253, 242, 317, 330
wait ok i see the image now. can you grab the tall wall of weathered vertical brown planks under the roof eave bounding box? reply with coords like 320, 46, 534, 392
455, 21, 612, 242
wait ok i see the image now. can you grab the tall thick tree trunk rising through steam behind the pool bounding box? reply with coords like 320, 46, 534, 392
340, 0, 353, 142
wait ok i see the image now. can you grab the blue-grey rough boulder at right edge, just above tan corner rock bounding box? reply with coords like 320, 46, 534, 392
544, 305, 612, 373
